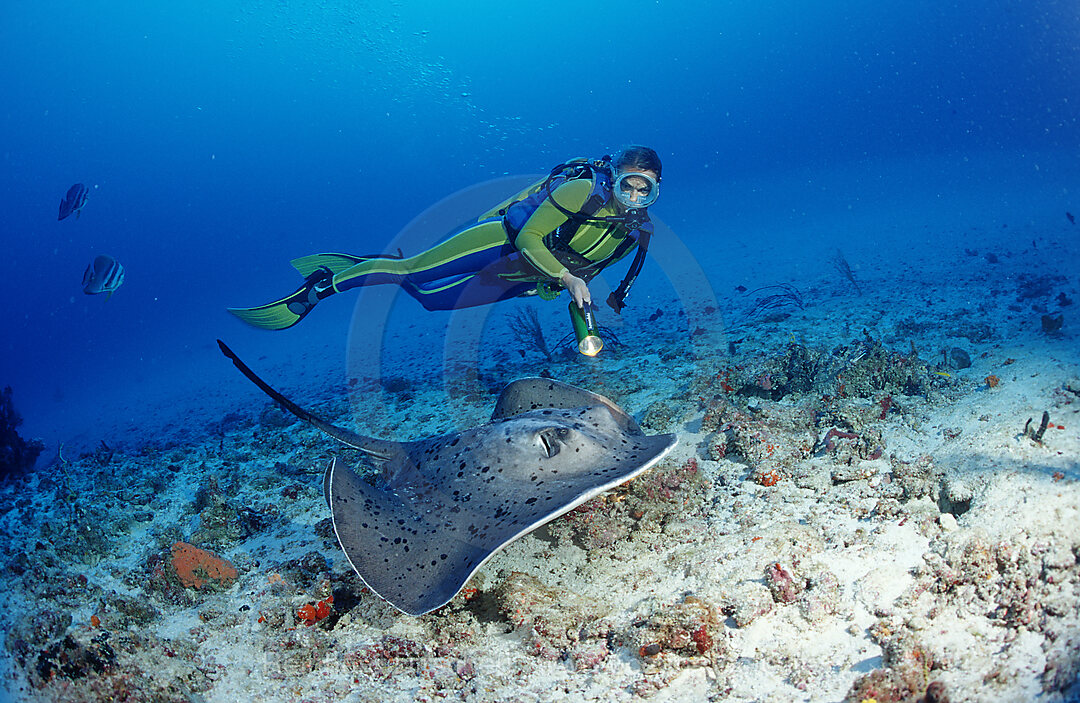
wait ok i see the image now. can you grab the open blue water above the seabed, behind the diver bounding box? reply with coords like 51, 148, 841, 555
0, 0, 1080, 462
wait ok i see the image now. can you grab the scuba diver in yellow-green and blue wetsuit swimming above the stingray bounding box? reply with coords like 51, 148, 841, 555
229, 145, 661, 329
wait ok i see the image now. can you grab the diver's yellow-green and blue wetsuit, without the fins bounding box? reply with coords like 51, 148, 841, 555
313, 178, 636, 310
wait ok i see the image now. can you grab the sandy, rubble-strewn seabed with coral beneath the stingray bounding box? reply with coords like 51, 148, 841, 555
0, 221, 1080, 703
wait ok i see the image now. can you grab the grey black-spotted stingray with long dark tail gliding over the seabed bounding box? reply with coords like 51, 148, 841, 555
218, 340, 676, 616
